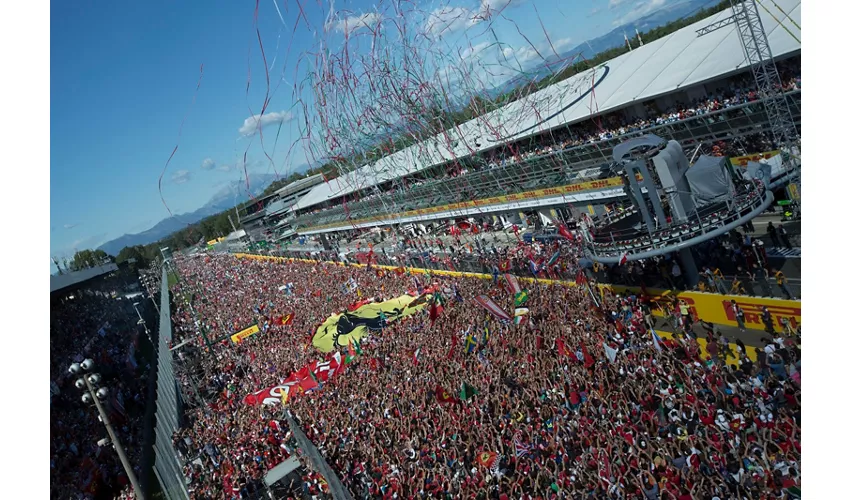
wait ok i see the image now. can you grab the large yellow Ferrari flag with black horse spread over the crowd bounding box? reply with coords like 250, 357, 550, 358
313, 295, 431, 352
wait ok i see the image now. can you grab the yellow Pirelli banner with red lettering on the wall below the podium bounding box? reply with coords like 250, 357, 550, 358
605, 285, 802, 330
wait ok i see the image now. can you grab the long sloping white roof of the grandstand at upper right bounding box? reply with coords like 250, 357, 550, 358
291, 0, 801, 211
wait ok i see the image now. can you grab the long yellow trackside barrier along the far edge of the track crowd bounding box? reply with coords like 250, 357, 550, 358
232, 253, 802, 330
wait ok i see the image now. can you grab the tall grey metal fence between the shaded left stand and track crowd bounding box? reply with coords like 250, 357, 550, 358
154, 266, 189, 500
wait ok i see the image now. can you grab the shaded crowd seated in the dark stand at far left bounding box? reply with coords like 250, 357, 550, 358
50, 272, 149, 500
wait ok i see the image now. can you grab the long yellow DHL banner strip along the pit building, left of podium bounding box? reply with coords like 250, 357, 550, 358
309, 177, 623, 230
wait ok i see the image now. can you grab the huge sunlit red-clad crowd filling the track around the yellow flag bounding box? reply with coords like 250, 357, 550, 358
173, 250, 801, 500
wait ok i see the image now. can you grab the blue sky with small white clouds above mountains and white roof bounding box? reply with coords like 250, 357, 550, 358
50, 0, 673, 270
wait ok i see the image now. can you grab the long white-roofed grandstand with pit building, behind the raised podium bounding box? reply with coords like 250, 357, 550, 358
276, 0, 801, 235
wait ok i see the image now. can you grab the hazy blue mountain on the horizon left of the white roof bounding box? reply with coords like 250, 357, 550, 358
98, 174, 277, 255
